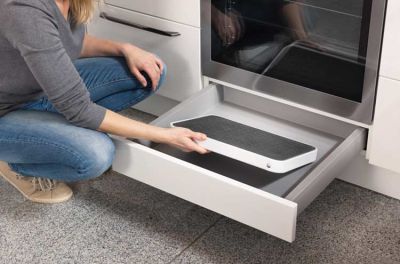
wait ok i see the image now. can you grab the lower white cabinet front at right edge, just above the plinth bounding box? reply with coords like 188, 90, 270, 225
369, 77, 400, 172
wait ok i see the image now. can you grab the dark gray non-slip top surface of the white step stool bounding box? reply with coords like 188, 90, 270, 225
174, 115, 315, 161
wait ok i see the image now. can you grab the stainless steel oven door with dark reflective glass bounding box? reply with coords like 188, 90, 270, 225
201, 0, 386, 124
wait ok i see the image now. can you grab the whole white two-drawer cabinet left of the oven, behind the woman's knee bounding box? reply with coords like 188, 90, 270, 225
88, 0, 201, 114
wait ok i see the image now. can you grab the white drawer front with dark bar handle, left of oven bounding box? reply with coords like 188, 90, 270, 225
88, 6, 201, 101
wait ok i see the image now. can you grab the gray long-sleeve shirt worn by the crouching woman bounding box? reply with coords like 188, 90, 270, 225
0, 0, 106, 129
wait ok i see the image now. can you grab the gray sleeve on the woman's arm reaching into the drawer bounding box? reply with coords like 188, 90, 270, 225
2, 1, 106, 129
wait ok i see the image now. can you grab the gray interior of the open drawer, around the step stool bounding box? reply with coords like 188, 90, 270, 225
143, 86, 352, 197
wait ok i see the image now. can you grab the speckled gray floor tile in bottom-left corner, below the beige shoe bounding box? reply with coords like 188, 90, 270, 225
0, 175, 113, 263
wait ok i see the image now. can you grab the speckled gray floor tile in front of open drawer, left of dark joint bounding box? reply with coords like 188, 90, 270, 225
43, 180, 220, 263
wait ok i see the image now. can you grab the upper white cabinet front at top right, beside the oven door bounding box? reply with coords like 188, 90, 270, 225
380, 0, 400, 81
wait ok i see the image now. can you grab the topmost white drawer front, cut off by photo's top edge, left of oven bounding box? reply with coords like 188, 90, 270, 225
104, 0, 200, 27
